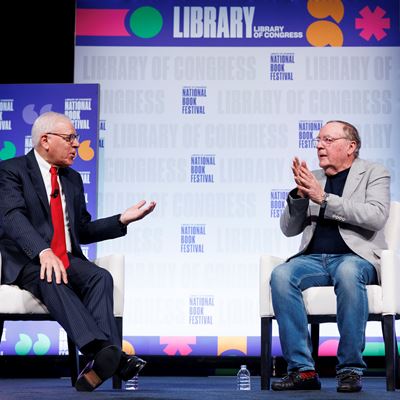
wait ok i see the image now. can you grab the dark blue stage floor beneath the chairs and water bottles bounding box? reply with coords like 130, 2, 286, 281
0, 376, 400, 400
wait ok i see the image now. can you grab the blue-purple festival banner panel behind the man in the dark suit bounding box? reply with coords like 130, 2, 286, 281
0, 83, 99, 355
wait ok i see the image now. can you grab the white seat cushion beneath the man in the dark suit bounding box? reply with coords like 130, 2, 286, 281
0, 285, 49, 314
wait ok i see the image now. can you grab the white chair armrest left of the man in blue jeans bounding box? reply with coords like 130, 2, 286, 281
260, 255, 285, 317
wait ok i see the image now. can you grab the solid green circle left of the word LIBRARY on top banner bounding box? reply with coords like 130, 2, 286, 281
129, 6, 163, 39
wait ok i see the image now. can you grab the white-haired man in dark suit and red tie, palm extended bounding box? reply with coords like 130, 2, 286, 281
0, 112, 156, 391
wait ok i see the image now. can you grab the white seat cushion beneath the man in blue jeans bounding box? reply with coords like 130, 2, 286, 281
303, 285, 383, 315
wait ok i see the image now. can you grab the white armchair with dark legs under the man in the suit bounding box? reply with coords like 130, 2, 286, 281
0, 254, 125, 389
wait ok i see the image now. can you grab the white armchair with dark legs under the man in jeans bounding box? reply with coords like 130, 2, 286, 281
260, 202, 400, 390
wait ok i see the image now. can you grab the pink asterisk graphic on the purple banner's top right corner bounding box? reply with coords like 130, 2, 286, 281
356, 6, 390, 41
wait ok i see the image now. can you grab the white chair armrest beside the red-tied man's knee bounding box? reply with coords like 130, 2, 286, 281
94, 254, 125, 317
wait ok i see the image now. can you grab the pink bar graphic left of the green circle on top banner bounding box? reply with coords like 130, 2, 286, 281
76, 8, 130, 36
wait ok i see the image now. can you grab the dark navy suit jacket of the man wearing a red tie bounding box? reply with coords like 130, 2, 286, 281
0, 150, 126, 283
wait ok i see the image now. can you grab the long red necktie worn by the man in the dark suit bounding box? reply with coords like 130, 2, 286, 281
50, 167, 69, 269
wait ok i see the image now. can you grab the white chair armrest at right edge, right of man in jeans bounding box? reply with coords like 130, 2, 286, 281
381, 250, 400, 315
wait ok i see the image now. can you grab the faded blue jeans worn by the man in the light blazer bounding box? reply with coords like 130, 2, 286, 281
271, 254, 377, 374
